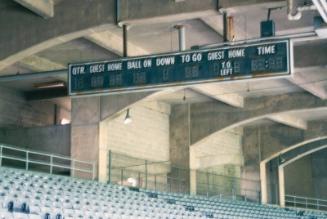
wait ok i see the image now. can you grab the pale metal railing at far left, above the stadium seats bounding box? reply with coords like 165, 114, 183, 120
0, 144, 97, 180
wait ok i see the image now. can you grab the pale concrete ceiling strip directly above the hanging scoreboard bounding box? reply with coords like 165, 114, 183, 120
0, 0, 317, 78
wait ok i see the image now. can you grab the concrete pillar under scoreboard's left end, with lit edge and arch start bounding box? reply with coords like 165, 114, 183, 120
71, 92, 152, 180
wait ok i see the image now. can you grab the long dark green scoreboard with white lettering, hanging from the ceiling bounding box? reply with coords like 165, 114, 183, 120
69, 40, 290, 95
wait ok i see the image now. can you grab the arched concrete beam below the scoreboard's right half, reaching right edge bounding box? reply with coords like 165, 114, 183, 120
191, 93, 327, 145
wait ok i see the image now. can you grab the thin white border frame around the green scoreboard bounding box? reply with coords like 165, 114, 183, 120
68, 39, 293, 96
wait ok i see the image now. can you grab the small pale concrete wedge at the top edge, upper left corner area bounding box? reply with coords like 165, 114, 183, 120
14, 0, 54, 18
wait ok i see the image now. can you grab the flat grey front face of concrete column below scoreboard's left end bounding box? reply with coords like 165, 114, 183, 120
71, 97, 100, 178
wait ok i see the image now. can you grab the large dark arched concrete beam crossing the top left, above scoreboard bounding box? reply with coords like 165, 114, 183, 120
0, 0, 217, 70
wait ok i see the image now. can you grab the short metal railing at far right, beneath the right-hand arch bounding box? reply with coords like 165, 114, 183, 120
285, 195, 327, 211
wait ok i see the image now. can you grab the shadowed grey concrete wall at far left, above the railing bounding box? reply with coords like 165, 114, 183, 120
0, 125, 70, 156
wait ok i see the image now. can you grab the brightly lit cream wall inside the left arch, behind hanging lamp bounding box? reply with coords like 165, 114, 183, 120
99, 102, 170, 181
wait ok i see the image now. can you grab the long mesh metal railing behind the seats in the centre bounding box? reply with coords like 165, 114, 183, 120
107, 151, 260, 202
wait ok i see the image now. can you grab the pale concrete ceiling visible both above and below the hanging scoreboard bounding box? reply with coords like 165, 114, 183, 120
0, 0, 327, 123
